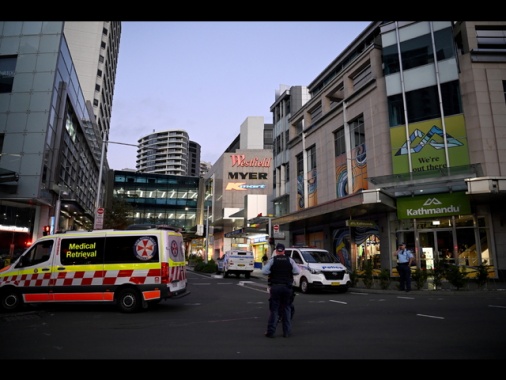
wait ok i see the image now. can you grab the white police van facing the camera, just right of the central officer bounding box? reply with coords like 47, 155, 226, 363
285, 247, 351, 293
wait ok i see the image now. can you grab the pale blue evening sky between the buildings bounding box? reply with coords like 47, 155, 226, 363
107, 21, 370, 170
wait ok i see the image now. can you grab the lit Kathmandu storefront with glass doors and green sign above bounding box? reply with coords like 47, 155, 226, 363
391, 192, 496, 269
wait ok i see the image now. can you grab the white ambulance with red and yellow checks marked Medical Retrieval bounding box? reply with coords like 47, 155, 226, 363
0, 226, 190, 313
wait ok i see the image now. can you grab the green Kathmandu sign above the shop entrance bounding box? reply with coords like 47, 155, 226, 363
397, 192, 471, 219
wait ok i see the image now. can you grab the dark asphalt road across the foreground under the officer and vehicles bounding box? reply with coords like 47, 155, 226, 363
0, 272, 506, 360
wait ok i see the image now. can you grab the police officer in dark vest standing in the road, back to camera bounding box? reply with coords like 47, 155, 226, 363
262, 244, 300, 338
